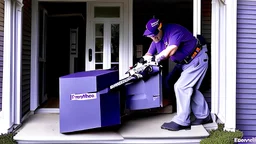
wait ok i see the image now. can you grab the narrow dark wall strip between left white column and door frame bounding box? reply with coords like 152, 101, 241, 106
21, 0, 31, 116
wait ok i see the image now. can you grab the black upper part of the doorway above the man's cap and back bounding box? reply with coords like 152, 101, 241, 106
133, 0, 193, 59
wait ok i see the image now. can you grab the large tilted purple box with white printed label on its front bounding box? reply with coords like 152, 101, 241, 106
59, 70, 121, 133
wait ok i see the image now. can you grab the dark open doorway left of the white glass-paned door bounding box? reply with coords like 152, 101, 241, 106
39, 2, 86, 108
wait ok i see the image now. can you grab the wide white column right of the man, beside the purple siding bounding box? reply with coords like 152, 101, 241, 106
211, 0, 237, 131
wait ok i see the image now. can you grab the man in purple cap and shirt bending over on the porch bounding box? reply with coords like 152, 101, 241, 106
143, 18, 212, 131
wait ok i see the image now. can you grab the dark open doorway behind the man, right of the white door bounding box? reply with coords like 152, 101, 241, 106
133, 0, 193, 112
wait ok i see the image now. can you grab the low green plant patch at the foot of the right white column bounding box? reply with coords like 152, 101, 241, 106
200, 124, 243, 144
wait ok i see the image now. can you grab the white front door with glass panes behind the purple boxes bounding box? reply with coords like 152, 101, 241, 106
86, 4, 123, 70
